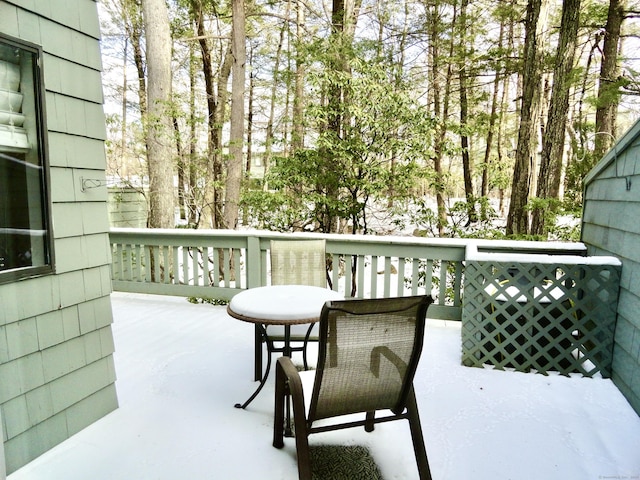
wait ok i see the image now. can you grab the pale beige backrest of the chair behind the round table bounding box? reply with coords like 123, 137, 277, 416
270, 240, 327, 288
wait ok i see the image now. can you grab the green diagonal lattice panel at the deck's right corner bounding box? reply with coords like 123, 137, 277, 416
462, 261, 620, 377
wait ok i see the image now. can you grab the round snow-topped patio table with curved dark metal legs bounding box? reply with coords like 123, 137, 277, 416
227, 285, 344, 408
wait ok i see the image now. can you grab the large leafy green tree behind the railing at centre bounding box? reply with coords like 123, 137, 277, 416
253, 41, 434, 233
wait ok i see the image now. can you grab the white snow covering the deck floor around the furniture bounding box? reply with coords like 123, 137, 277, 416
8, 293, 640, 480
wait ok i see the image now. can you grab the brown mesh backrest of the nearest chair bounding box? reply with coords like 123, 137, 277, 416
308, 296, 433, 422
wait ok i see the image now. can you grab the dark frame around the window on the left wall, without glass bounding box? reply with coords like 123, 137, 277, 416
0, 32, 55, 285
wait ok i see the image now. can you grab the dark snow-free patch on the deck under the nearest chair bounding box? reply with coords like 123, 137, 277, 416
310, 445, 382, 480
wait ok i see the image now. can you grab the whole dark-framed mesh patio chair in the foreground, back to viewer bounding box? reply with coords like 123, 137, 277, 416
273, 296, 433, 480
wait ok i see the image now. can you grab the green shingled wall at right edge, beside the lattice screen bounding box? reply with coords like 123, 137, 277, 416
582, 121, 640, 414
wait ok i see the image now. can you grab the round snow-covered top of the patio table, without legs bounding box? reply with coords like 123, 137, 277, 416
227, 285, 344, 325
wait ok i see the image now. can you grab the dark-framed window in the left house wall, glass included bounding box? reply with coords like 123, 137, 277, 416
0, 36, 53, 283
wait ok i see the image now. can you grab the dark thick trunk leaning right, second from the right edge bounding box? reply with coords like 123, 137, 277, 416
531, 0, 580, 235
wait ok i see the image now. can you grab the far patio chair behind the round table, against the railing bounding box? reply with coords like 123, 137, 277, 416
254, 240, 327, 380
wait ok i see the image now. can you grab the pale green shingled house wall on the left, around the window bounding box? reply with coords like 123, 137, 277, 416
0, 0, 118, 473
